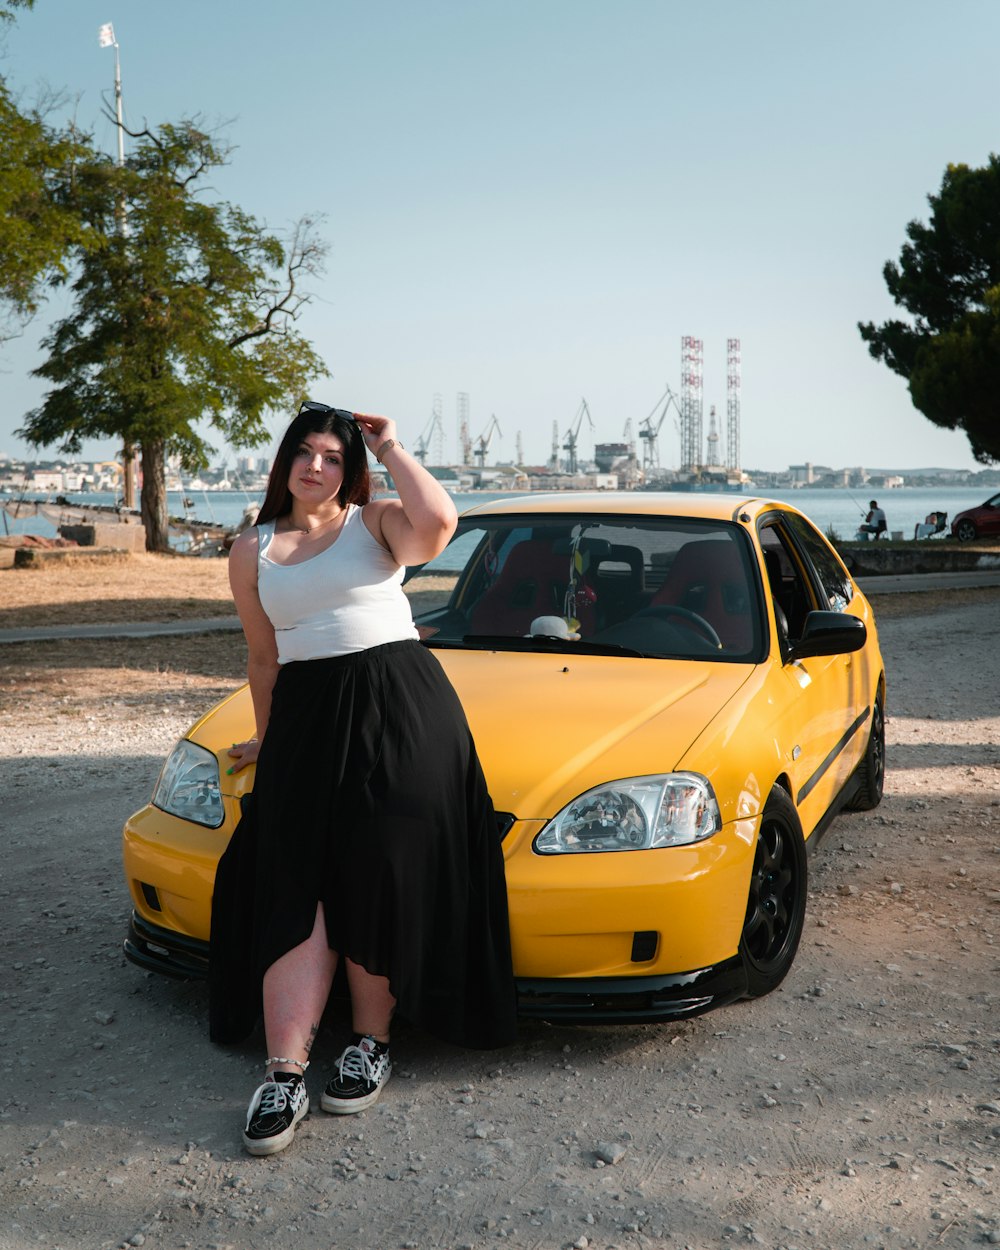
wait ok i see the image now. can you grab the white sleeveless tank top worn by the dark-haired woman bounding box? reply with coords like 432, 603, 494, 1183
258, 504, 419, 664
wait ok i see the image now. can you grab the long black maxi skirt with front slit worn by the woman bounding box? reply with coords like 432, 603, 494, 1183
209, 641, 516, 1048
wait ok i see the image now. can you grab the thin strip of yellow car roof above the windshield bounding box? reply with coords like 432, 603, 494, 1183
461, 490, 796, 524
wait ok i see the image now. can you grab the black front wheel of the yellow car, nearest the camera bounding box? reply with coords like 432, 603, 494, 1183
740, 785, 808, 999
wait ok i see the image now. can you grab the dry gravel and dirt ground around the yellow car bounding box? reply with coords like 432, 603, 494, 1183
0, 556, 1000, 1250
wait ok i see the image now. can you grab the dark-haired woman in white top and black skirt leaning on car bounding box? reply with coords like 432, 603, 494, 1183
210, 403, 515, 1155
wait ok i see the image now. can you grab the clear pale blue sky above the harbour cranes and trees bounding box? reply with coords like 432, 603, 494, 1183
0, 0, 1000, 469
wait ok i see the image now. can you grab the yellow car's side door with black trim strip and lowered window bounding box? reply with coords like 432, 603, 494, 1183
759, 513, 868, 834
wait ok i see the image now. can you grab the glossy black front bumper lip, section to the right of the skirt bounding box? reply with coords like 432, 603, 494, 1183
516, 955, 746, 1024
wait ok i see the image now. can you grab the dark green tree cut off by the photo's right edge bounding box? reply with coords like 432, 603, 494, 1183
858, 155, 1000, 464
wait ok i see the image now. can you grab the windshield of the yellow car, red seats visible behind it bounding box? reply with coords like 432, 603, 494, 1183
406, 513, 765, 664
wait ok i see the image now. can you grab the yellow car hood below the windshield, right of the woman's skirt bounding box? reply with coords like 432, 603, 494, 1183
434, 650, 754, 820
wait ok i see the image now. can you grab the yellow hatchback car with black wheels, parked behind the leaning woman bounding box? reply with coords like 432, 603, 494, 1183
124, 491, 885, 1021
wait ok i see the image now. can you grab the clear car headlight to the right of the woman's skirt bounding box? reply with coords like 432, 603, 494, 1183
534, 773, 723, 855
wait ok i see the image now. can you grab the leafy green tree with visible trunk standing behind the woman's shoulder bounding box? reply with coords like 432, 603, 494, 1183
18, 121, 326, 551
